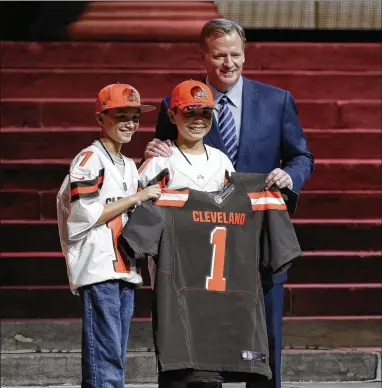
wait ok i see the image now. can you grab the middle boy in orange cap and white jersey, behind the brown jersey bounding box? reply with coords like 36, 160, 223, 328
139, 80, 234, 191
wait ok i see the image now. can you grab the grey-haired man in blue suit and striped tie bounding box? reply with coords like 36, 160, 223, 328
145, 19, 314, 388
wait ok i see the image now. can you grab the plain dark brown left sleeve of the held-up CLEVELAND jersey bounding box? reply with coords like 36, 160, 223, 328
118, 201, 164, 259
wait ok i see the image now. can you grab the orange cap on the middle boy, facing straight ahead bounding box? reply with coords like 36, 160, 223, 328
170, 80, 214, 110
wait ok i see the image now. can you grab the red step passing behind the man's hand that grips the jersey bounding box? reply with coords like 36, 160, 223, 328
2, 159, 381, 190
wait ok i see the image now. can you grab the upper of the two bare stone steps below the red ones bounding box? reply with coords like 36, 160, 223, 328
1, 316, 382, 354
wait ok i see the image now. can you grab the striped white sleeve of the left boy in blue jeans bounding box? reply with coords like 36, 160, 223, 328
67, 150, 105, 240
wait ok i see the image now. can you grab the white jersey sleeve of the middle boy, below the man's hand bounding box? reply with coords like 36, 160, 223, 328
138, 157, 171, 188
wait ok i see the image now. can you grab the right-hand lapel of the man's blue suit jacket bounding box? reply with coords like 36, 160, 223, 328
236, 77, 258, 167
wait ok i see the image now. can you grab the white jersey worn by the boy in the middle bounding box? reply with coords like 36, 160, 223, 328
139, 144, 235, 191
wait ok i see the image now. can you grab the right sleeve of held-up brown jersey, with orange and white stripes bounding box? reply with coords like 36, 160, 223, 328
253, 188, 302, 275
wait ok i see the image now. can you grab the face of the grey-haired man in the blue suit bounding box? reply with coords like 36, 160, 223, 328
201, 31, 245, 92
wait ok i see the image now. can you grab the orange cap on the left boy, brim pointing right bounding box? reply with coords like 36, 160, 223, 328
96, 84, 155, 113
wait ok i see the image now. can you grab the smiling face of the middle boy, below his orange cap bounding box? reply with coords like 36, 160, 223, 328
169, 108, 212, 143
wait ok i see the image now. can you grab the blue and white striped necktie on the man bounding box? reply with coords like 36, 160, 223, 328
219, 95, 238, 166
